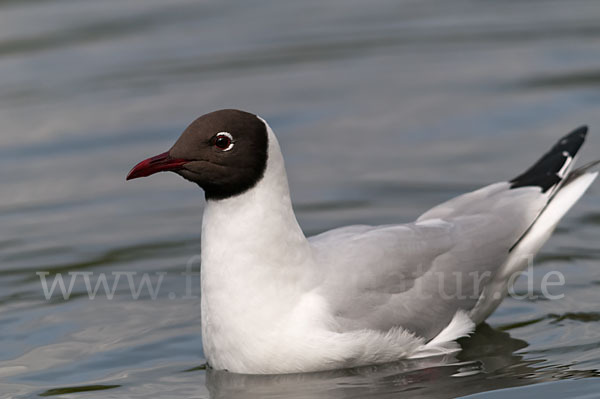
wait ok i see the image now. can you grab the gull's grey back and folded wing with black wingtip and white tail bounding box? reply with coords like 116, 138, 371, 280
310, 129, 596, 339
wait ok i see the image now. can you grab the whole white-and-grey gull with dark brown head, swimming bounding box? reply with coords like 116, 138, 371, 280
127, 109, 600, 374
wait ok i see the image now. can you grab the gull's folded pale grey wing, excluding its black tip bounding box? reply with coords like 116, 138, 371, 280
310, 183, 547, 339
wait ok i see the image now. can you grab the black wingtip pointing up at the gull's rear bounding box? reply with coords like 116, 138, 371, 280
510, 125, 588, 192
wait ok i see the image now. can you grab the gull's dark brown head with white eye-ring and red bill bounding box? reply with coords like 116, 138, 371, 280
127, 109, 269, 199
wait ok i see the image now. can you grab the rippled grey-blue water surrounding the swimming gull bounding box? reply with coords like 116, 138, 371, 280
0, 0, 600, 398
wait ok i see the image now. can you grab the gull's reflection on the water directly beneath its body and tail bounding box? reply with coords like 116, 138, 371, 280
206, 323, 595, 399
